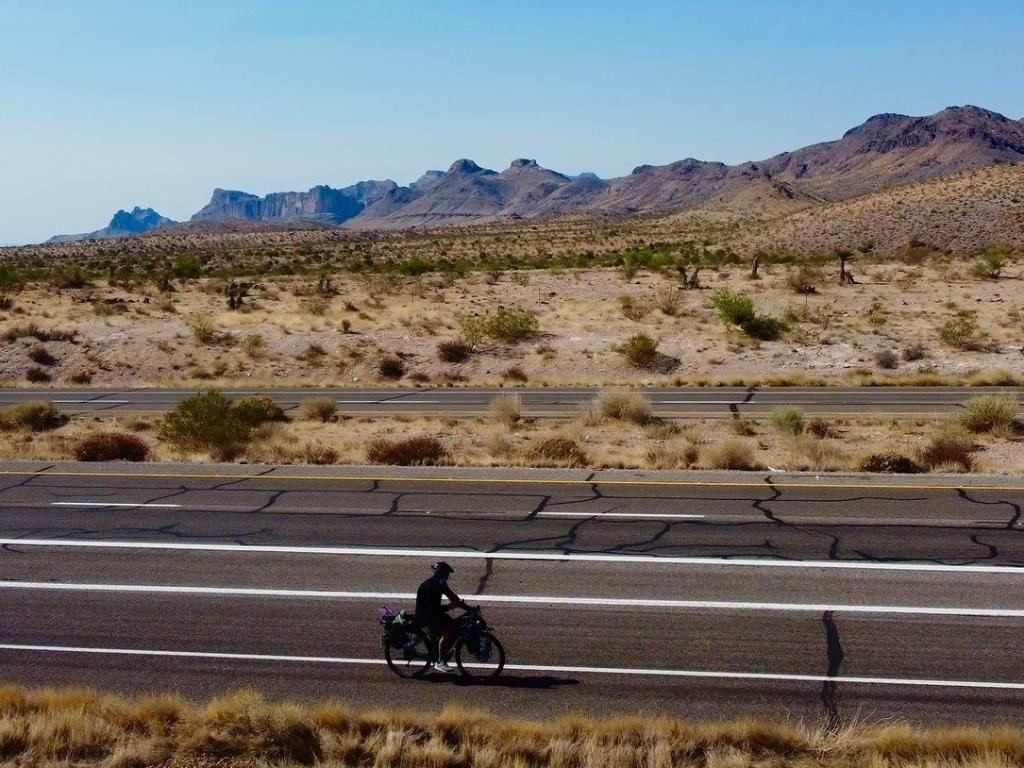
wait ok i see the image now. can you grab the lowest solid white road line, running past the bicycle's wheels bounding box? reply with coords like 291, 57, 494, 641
0, 643, 1024, 690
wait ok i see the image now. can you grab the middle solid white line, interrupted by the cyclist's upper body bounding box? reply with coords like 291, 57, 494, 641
0, 581, 1024, 618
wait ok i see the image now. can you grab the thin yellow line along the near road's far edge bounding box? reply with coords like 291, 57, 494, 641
0, 469, 1024, 492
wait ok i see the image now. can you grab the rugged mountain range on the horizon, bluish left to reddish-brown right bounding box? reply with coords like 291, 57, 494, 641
50, 105, 1024, 242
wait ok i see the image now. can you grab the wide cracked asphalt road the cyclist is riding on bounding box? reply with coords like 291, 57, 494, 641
0, 467, 1024, 724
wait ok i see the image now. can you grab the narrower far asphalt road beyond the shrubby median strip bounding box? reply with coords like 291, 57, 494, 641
0, 387, 1021, 418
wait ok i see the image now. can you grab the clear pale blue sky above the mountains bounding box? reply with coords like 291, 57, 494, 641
0, 0, 1024, 245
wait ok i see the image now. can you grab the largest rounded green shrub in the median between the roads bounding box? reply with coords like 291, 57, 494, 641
157, 389, 252, 451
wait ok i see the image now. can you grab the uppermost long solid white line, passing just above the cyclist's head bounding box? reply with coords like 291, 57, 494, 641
0, 539, 1024, 575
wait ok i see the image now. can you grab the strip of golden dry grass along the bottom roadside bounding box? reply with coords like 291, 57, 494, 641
0, 686, 1024, 768
